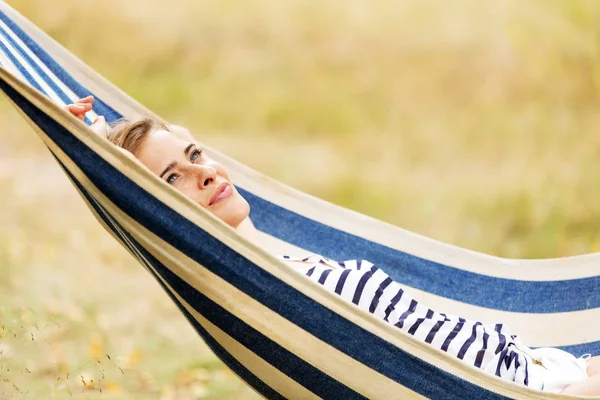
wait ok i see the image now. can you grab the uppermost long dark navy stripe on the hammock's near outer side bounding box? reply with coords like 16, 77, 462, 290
0, 72, 504, 399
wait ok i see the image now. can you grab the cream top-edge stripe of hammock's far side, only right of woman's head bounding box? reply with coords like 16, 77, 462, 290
218, 149, 600, 281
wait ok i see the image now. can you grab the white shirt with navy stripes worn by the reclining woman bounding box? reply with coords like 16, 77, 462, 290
281, 254, 543, 389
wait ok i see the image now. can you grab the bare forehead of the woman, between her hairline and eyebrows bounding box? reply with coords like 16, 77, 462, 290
137, 129, 190, 175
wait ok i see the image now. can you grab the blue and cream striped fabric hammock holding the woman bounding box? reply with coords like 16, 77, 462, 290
0, 2, 600, 399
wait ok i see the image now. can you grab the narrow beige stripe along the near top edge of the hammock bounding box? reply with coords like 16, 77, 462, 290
0, 52, 596, 398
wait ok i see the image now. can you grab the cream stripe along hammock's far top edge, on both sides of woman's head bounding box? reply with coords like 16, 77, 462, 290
0, 2, 600, 280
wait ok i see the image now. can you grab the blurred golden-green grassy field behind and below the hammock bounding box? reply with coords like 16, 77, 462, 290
0, 0, 600, 400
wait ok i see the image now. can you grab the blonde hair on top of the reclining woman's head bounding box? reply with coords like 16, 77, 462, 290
108, 117, 170, 156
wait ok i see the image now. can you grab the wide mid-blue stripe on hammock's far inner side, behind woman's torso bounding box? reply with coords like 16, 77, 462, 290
240, 189, 600, 314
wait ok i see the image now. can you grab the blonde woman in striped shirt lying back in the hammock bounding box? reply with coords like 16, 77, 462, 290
67, 96, 600, 395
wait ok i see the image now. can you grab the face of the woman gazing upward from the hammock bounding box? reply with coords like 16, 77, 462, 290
137, 129, 250, 228
